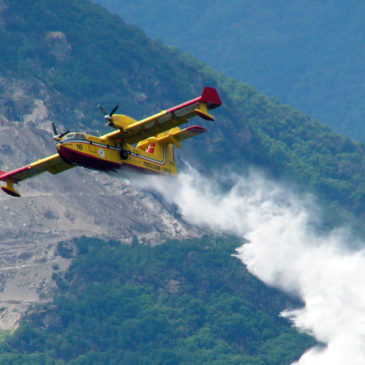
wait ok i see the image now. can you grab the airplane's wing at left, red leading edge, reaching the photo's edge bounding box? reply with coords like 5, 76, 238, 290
0, 153, 74, 197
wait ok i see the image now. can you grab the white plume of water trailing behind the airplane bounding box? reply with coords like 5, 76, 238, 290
134, 170, 365, 365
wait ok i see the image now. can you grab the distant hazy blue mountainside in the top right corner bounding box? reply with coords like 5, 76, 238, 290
95, 0, 365, 141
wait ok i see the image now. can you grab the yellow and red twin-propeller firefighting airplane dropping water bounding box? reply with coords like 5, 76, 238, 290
0, 87, 222, 197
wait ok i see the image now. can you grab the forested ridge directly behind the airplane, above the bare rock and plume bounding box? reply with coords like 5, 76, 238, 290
0, 0, 365, 222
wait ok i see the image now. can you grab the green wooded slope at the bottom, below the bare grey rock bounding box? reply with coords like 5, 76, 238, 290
0, 237, 314, 365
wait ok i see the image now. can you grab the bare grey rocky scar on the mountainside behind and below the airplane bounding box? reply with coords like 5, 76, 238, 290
0, 121, 199, 330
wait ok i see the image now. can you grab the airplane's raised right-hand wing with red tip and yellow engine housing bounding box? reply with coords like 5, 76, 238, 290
102, 87, 222, 144
